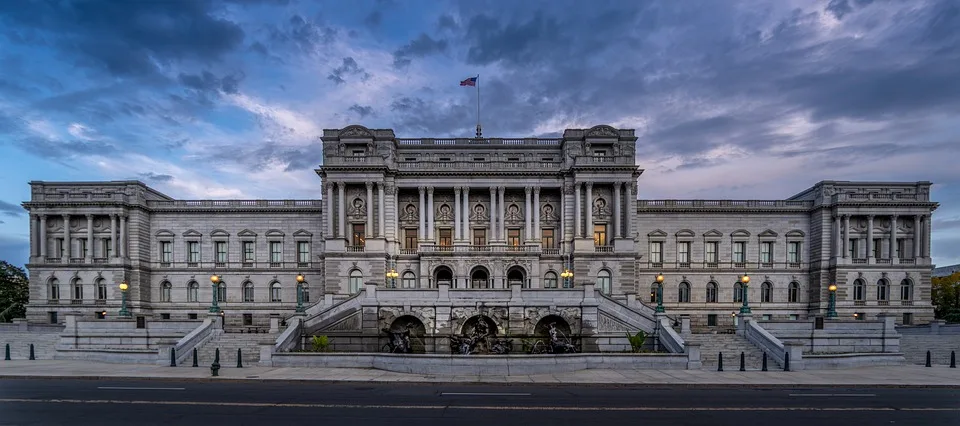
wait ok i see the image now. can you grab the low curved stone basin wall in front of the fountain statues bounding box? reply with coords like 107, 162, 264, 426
261, 353, 699, 376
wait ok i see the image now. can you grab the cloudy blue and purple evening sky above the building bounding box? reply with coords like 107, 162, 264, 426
0, 0, 960, 265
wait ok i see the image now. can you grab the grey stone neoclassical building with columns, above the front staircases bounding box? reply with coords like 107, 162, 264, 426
23, 126, 937, 330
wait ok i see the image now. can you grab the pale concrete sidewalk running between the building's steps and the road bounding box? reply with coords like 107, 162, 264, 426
0, 360, 960, 388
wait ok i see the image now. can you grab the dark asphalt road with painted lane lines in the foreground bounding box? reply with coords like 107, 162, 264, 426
0, 380, 960, 426
